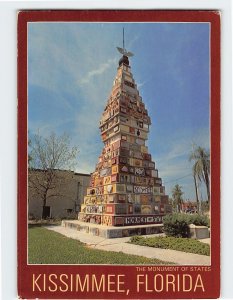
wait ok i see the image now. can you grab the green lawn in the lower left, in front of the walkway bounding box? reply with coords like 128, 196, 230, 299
28, 227, 171, 265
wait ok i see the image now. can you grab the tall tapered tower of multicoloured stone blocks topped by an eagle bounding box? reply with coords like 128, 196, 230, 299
79, 34, 172, 226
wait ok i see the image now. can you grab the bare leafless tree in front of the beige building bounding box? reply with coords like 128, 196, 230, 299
28, 132, 78, 218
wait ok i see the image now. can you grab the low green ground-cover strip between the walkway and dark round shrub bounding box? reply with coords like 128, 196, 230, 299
130, 236, 210, 256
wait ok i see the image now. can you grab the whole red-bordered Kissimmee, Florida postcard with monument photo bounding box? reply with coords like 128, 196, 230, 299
18, 10, 220, 299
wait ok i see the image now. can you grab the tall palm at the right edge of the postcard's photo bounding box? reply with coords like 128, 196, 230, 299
189, 146, 210, 202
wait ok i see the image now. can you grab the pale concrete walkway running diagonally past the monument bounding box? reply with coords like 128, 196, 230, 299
46, 226, 210, 265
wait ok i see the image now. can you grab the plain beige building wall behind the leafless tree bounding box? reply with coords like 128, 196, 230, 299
28, 170, 90, 218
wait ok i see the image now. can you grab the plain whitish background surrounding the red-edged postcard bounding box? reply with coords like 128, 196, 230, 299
0, 0, 233, 300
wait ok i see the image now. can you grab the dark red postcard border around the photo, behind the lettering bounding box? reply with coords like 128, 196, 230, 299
18, 10, 220, 299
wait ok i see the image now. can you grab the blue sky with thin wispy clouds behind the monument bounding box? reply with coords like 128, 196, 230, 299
28, 23, 210, 199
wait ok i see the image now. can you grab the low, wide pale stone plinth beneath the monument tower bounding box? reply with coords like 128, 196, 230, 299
62, 220, 163, 239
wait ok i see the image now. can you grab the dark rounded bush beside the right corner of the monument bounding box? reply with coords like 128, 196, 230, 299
163, 214, 190, 238
